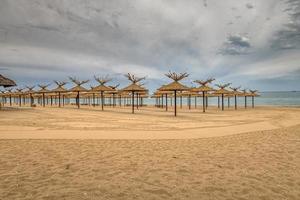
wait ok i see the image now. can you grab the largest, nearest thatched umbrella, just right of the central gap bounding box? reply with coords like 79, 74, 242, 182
160, 72, 189, 117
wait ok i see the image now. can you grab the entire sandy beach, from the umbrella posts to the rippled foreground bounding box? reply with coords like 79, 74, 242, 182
0, 107, 300, 200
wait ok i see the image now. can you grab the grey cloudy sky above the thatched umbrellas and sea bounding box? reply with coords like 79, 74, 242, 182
0, 0, 300, 91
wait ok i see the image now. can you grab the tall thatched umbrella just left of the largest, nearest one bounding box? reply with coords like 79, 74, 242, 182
121, 73, 147, 113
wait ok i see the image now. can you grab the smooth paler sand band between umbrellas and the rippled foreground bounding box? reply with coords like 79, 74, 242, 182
0, 107, 300, 139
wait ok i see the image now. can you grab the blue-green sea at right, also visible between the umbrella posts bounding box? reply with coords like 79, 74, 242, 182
145, 91, 300, 106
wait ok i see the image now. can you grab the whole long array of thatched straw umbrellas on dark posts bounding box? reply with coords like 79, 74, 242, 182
0, 72, 257, 116
